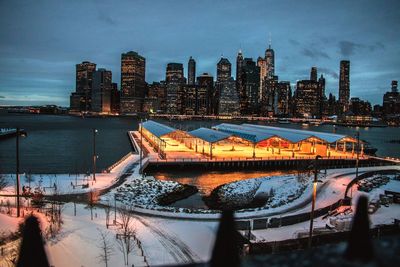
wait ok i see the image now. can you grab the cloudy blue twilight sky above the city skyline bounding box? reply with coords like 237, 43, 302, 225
0, 0, 400, 106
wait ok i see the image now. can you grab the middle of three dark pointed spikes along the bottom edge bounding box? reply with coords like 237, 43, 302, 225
211, 210, 240, 267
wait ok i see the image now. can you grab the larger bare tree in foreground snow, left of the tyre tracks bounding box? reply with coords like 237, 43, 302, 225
117, 207, 136, 265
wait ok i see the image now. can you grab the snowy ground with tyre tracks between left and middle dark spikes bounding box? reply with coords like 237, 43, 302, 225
46, 203, 217, 267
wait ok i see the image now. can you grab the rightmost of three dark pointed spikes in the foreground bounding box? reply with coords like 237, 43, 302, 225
344, 196, 374, 262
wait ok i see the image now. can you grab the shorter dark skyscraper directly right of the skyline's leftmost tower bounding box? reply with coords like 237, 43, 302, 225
92, 69, 113, 113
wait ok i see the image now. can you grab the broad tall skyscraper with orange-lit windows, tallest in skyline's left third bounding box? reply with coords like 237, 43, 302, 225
121, 51, 146, 113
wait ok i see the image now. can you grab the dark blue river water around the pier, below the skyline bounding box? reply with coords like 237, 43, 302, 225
0, 114, 400, 175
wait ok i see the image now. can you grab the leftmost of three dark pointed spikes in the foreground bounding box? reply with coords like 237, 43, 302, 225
17, 216, 49, 267
